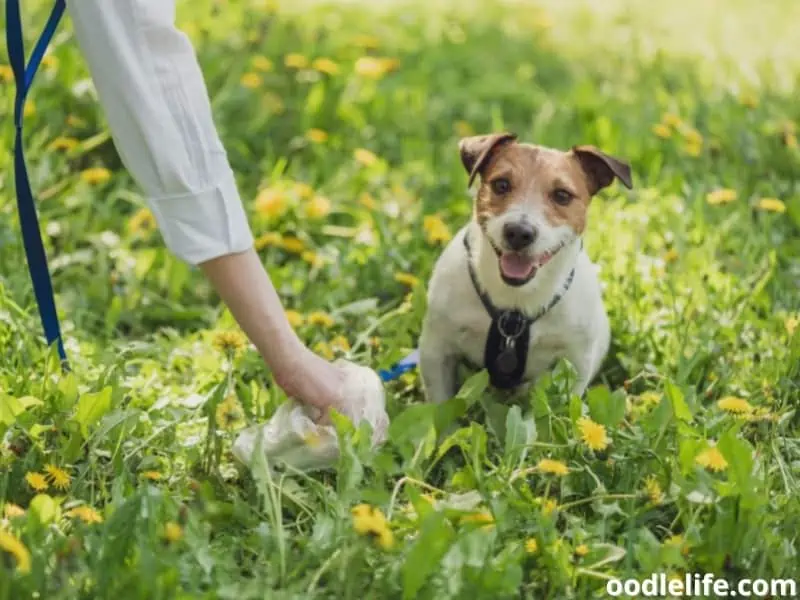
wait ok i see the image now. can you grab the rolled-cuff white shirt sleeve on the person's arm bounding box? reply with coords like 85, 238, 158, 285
67, 0, 253, 265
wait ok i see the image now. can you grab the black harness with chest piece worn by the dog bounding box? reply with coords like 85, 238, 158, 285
464, 232, 583, 389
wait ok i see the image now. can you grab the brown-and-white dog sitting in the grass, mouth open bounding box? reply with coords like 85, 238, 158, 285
419, 133, 633, 403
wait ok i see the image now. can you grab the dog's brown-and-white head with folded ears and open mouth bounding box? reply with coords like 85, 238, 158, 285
459, 133, 632, 286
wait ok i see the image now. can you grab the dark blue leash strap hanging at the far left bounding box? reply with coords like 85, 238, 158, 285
6, 0, 68, 368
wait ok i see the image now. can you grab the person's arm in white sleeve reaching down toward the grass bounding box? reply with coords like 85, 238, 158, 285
67, 0, 342, 408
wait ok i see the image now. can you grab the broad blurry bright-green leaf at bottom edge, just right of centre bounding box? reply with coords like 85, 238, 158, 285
403, 512, 456, 600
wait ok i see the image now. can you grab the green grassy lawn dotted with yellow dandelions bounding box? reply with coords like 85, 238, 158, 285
0, 0, 800, 600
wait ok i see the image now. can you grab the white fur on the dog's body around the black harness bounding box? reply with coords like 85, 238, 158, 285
420, 220, 610, 402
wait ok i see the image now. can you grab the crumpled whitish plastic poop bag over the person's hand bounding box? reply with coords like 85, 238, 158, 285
232, 360, 389, 471
